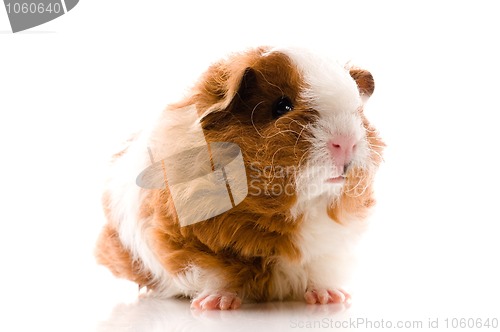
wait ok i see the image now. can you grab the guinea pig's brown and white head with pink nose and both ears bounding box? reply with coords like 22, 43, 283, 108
194, 48, 383, 218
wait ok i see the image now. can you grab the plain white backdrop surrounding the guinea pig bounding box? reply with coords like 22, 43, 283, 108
0, 0, 500, 331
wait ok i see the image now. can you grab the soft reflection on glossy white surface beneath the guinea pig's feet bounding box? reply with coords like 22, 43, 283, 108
97, 298, 352, 332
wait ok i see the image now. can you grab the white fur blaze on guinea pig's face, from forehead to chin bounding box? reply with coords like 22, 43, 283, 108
270, 48, 369, 207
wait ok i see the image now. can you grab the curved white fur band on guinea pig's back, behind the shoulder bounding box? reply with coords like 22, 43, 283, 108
106, 105, 205, 296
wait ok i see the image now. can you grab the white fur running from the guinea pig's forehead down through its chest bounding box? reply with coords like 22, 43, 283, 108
273, 49, 369, 289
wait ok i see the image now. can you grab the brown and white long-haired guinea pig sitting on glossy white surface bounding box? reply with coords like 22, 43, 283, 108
96, 47, 385, 310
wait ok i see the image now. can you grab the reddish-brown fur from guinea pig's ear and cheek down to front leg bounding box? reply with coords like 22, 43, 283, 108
146, 50, 315, 300
